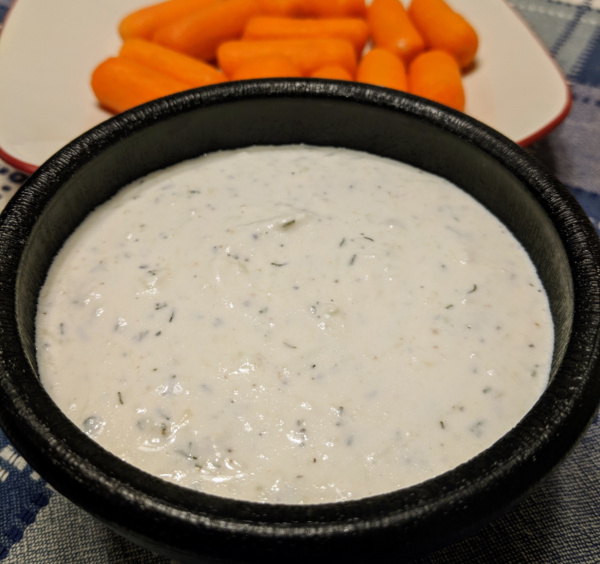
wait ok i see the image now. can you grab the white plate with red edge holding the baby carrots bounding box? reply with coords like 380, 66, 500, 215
0, 0, 571, 173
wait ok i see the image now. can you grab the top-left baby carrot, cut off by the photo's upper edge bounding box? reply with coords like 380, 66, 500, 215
119, 0, 222, 39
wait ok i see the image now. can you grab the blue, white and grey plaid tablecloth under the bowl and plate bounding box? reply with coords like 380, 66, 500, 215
0, 0, 600, 564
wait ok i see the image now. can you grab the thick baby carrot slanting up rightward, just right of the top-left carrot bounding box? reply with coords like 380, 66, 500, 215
153, 0, 260, 61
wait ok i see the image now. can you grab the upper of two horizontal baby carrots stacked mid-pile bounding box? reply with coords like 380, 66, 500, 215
242, 16, 369, 53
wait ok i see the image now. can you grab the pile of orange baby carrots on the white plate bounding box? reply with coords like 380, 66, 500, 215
91, 0, 478, 113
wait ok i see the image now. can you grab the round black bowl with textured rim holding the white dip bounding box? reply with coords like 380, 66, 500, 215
0, 80, 600, 562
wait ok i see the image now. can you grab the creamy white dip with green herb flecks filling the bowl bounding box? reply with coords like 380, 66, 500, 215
37, 146, 553, 503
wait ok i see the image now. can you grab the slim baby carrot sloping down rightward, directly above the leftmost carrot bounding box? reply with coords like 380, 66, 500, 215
119, 39, 226, 88
